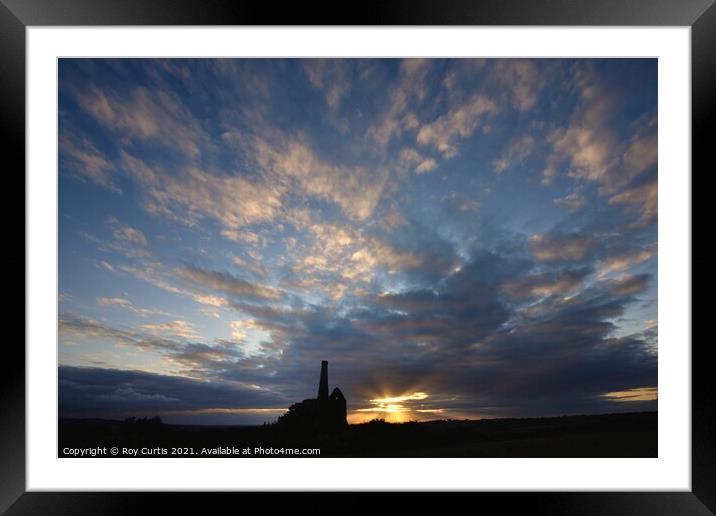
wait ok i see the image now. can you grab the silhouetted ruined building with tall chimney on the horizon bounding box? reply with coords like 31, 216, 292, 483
277, 360, 348, 432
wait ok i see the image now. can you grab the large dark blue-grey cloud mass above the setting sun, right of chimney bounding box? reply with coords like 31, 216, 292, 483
284, 248, 656, 415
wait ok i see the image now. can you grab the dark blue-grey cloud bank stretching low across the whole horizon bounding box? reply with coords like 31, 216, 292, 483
59, 240, 657, 422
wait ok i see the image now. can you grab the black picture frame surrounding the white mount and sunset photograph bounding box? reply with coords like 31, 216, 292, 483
0, 0, 716, 514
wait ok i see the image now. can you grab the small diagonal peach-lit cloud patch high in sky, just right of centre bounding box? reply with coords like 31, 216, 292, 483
417, 93, 497, 159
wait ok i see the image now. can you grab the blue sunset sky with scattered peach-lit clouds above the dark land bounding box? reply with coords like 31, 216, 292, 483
58, 59, 658, 424
